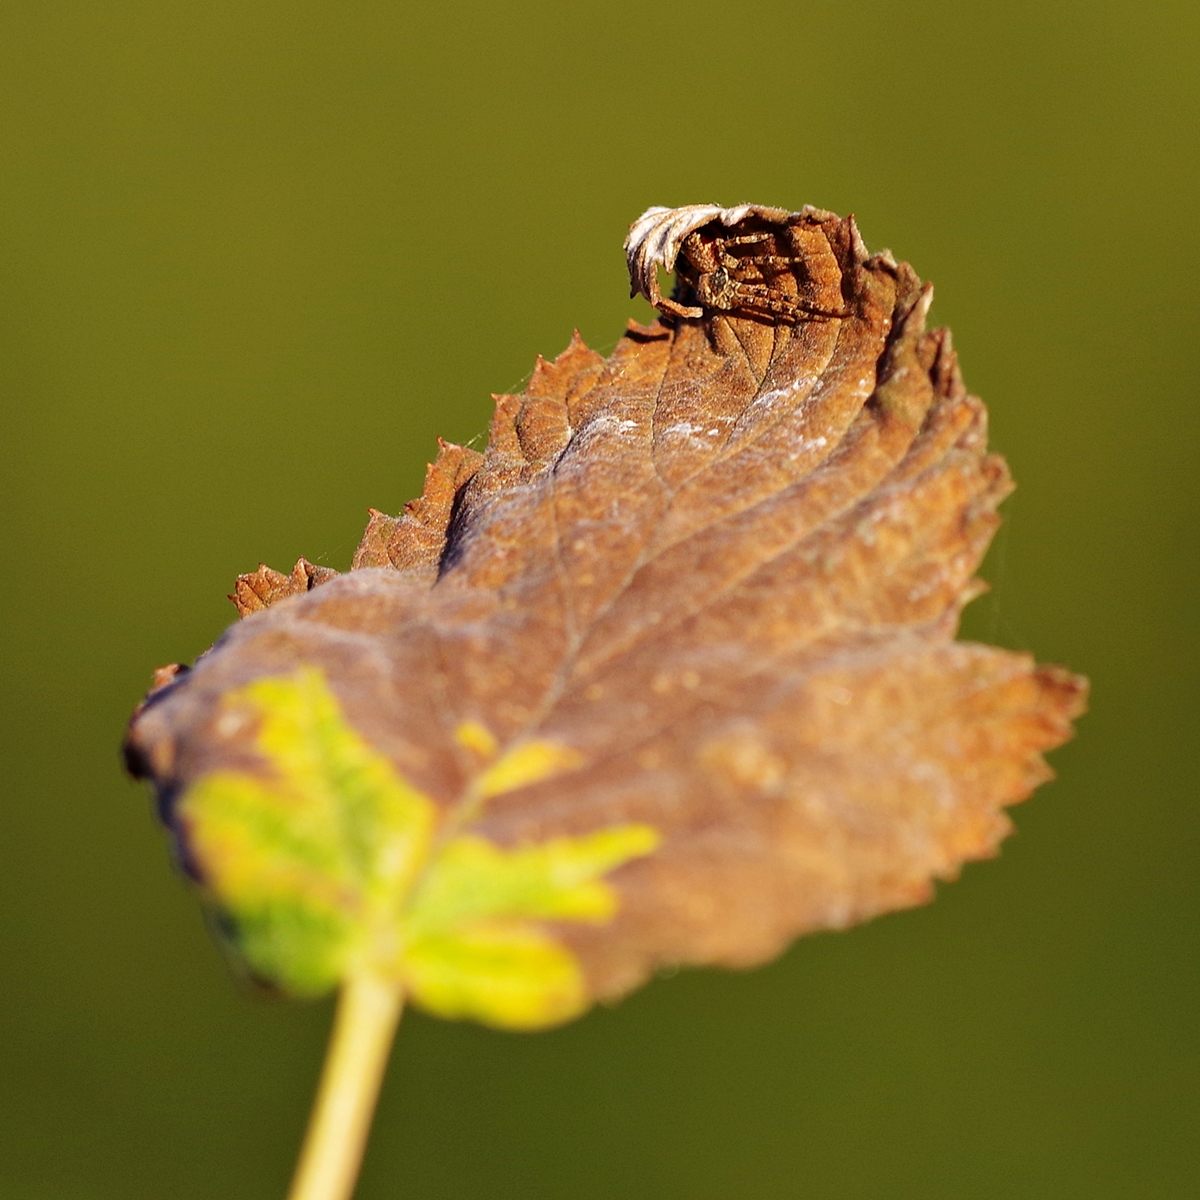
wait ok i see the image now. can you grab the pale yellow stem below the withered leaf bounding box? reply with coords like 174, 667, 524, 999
288, 974, 404, 1200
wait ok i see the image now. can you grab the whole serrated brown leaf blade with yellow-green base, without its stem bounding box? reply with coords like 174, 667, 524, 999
127, 205, 1086, 1028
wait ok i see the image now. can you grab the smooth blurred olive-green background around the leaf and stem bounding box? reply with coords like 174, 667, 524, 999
0, 0, 1200, 1200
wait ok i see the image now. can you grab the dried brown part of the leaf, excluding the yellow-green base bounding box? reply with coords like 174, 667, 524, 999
130, 206, 1085, 1012
